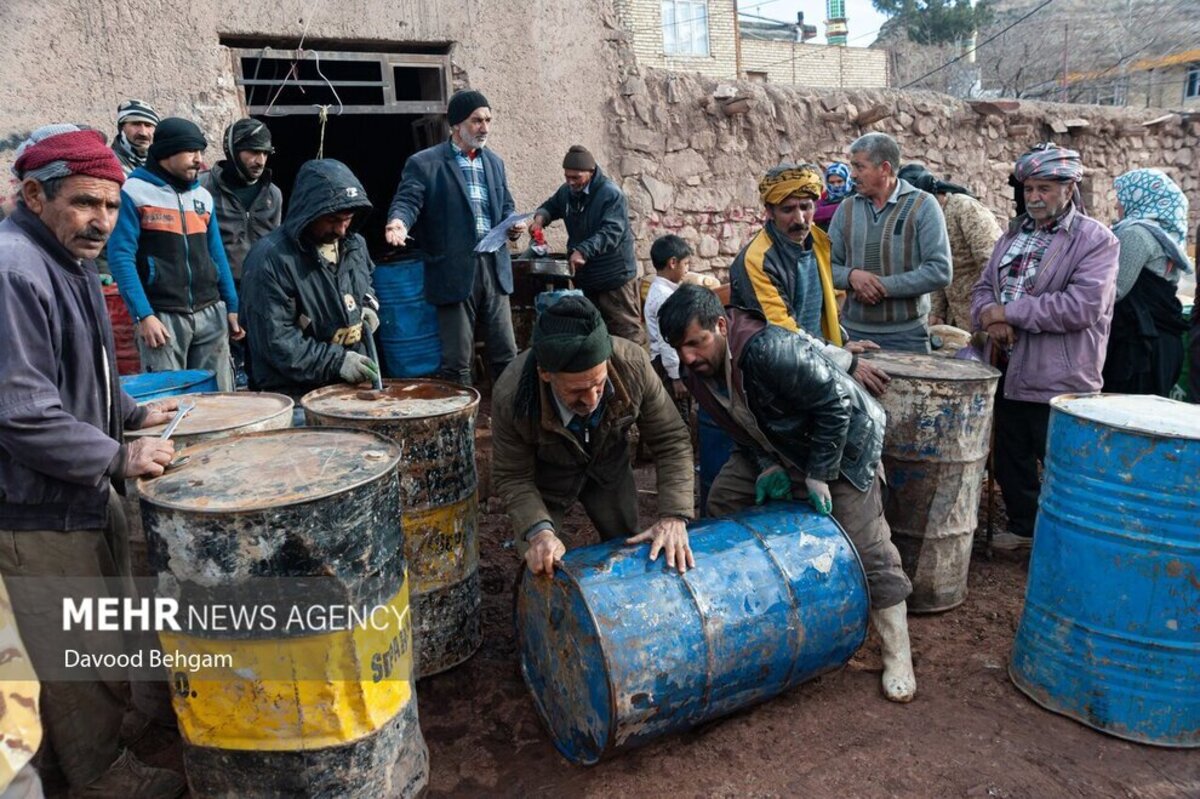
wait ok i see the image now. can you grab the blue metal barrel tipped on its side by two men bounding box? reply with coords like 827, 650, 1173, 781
517, 503, 868, 764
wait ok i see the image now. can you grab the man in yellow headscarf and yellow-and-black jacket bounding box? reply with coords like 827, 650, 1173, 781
730, 163, 887, 396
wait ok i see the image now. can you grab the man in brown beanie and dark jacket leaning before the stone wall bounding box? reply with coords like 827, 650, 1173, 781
529, 144, 647, 346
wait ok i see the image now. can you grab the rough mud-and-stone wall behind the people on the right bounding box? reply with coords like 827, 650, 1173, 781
608, 70, 1200, 278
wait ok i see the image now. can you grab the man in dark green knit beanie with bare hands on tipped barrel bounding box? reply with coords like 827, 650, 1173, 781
492, 296, 695, 575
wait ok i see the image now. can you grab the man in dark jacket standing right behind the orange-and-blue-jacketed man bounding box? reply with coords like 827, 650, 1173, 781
200, 119, 283, 388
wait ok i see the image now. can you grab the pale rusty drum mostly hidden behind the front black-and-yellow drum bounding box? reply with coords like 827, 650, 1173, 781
122, 391, 294, 568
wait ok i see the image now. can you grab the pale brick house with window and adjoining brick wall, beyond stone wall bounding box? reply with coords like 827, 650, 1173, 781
616, 0, 888, 89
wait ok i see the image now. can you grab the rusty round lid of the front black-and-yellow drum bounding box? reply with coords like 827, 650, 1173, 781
138, 427, 400, 513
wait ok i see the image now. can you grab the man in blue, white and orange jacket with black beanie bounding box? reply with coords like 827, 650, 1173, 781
108, 118, 246, 391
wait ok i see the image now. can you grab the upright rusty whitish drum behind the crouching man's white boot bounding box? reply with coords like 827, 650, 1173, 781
869, 352, 1000, 613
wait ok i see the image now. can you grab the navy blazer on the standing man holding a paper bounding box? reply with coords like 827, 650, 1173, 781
388, 139, 515, 305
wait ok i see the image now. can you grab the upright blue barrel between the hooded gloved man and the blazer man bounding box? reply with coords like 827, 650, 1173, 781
372, 259, 442, 378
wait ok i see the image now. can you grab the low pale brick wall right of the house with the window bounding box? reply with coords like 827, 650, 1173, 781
742, 38, 888, 89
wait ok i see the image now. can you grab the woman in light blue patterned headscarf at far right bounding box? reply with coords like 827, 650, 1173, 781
1104, 169, 1192, 397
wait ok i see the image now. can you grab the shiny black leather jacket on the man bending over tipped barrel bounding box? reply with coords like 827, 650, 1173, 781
686, 308, 887, 491
